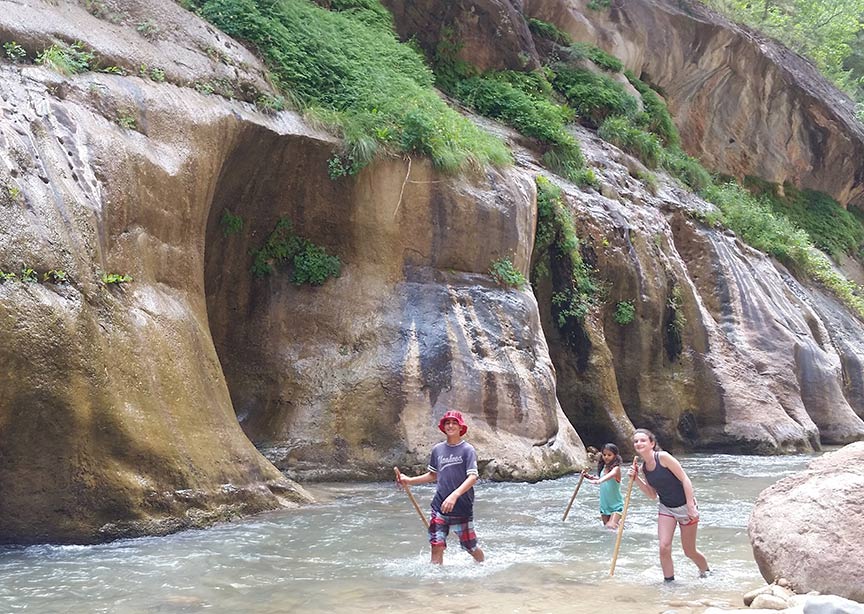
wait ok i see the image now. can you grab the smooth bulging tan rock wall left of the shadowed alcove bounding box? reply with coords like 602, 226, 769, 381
0, 66, 309, 543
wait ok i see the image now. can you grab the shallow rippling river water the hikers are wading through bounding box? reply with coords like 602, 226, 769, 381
0, 455, 813, 614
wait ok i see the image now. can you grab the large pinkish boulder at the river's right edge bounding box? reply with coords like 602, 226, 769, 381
748, 442, 864, 601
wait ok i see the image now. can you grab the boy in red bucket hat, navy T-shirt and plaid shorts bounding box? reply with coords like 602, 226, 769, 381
396, 411, 485, 565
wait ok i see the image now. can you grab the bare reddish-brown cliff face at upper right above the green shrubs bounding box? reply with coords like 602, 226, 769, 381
525, 0, 864, 206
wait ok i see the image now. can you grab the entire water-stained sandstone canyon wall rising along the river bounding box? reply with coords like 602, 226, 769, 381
0, 0, 864, 543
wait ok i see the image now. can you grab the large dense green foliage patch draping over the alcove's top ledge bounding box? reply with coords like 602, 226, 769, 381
200, 0, 511, 171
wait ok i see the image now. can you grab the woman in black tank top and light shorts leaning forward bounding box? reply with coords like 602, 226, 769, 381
630, 429, 710, 582
